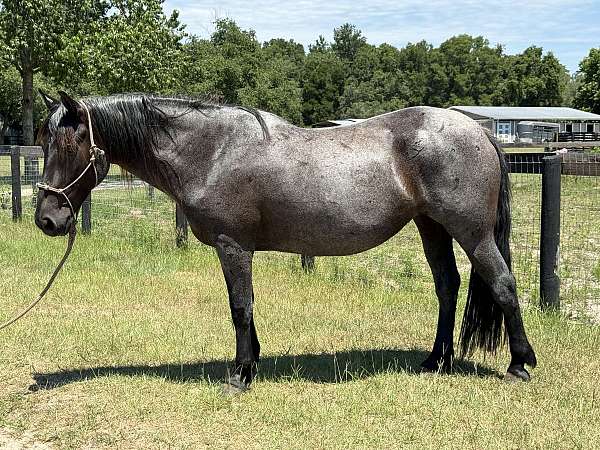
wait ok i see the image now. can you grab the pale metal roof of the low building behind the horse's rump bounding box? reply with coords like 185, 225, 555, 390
450, 106, 600, 120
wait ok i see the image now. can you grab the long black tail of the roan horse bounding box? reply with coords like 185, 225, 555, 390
460, 133, 511, 356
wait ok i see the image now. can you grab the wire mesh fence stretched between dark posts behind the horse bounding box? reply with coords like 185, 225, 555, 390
0, 151, 600, 321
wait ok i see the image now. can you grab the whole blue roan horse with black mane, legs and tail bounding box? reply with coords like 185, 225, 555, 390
35, 93, 536, 390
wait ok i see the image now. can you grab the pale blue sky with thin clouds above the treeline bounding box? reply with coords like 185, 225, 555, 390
165, 0, 600, 72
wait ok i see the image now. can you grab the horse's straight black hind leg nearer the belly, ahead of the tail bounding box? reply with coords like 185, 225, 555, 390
415, 216, 460, 371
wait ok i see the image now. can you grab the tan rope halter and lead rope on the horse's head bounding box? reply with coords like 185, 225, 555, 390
0, 102, 99, 331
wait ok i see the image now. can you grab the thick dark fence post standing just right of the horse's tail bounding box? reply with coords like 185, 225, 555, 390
540, 155, 561, 310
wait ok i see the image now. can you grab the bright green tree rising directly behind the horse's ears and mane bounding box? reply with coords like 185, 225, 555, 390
60, 0, 185, 95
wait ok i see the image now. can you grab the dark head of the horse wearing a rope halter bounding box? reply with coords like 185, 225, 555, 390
35, 91, 109, 236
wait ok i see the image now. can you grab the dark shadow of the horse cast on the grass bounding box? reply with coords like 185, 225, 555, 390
29, 349, 499, 391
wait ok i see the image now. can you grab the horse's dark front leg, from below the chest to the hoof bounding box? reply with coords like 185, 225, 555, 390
215, 235, 260, 391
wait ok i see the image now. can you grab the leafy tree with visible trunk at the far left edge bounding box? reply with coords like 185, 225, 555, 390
0, 0, 108, 145
